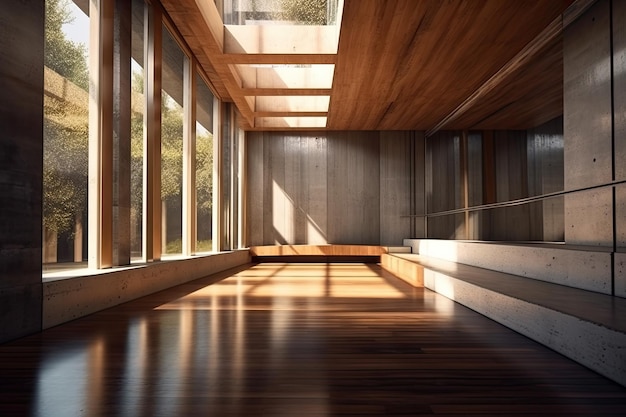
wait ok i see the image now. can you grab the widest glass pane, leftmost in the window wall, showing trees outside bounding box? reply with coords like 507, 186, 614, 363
43, 0, 89, 272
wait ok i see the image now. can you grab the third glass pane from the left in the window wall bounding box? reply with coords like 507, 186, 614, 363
161, 27, 187, 254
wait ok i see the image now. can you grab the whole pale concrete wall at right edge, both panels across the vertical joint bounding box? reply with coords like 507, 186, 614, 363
563, 0, 626, 297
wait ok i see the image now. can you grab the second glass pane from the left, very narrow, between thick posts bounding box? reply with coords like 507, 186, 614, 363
130, 0, 145, 261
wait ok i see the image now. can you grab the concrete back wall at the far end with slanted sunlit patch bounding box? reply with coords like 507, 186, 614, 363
246, 132, 424, 246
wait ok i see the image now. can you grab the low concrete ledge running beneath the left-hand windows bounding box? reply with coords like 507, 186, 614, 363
42, 250, 250, 329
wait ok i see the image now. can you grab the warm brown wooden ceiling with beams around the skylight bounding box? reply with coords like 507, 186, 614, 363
162, 0, 576, 132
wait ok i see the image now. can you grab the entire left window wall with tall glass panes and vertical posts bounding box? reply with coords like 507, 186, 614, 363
42, 0, 238, 277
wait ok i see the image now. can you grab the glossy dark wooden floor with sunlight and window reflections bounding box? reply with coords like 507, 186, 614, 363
0, 263, 626, 417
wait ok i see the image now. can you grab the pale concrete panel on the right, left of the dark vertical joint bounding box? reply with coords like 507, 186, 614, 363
563, 0, 613, 247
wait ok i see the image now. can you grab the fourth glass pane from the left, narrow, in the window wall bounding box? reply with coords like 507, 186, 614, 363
196, 75, 213, 252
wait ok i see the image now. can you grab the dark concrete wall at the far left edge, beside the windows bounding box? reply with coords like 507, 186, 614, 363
0, 1, 44, 342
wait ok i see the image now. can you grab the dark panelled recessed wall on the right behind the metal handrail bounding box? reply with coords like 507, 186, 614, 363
426, 117, 564, 241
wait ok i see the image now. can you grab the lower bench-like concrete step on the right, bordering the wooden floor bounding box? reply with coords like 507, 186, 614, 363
389, 255, 626, 386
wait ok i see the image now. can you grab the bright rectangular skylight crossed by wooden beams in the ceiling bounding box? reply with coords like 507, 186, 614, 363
207, 0, 343, 129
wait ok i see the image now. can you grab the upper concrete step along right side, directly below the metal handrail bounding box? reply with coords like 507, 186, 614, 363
404, 239, 613, 294
